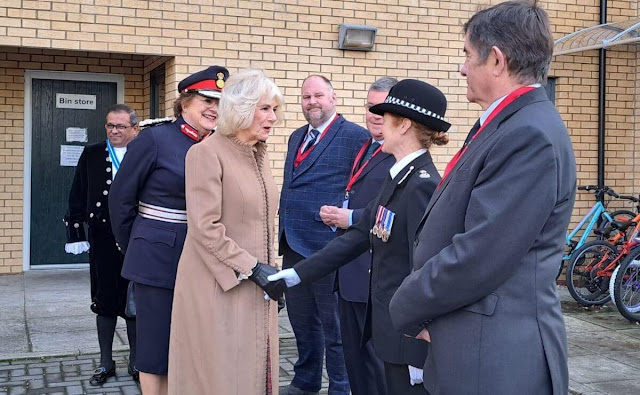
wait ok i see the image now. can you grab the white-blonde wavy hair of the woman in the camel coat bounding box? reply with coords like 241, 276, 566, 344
217, 69, 284, 135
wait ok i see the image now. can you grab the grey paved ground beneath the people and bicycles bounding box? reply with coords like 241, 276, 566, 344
0, 270, 640, 395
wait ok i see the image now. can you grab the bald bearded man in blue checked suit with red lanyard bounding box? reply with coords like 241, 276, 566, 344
279, 75, 370, 395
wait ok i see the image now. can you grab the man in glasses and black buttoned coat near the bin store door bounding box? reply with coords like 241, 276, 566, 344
64, 104, 138, 385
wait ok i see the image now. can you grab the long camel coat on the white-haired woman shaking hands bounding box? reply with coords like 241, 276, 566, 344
169, 133, 279, 395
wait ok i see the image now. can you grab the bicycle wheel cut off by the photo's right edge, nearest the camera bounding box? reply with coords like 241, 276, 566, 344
611, 247, 640, 322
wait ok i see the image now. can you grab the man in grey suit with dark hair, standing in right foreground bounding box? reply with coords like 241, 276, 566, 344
390, 1, 576, 395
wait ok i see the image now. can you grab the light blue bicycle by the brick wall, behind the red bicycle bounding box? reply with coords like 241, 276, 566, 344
556, 185, 640, 279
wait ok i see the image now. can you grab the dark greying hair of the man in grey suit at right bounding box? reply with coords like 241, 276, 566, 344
463, 0, 553, 84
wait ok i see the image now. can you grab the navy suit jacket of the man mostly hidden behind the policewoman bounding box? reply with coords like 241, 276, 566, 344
337, 144, 396, 303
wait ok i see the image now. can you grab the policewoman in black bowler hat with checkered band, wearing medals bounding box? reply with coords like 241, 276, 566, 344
269, 79, 450, 395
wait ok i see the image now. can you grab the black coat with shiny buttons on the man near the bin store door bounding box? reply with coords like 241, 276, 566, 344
65, 141, 129, 317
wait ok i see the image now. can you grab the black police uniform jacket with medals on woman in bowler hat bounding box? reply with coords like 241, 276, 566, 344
295, 152, 440, 367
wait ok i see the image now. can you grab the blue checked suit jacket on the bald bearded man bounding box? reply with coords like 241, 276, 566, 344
278, 115, 370, 257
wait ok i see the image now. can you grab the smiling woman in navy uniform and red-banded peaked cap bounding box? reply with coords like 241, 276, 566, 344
109, 66, 229, 394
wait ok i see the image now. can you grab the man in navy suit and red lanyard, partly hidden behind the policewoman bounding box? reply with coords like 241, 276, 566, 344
320, 77, 398, 395
